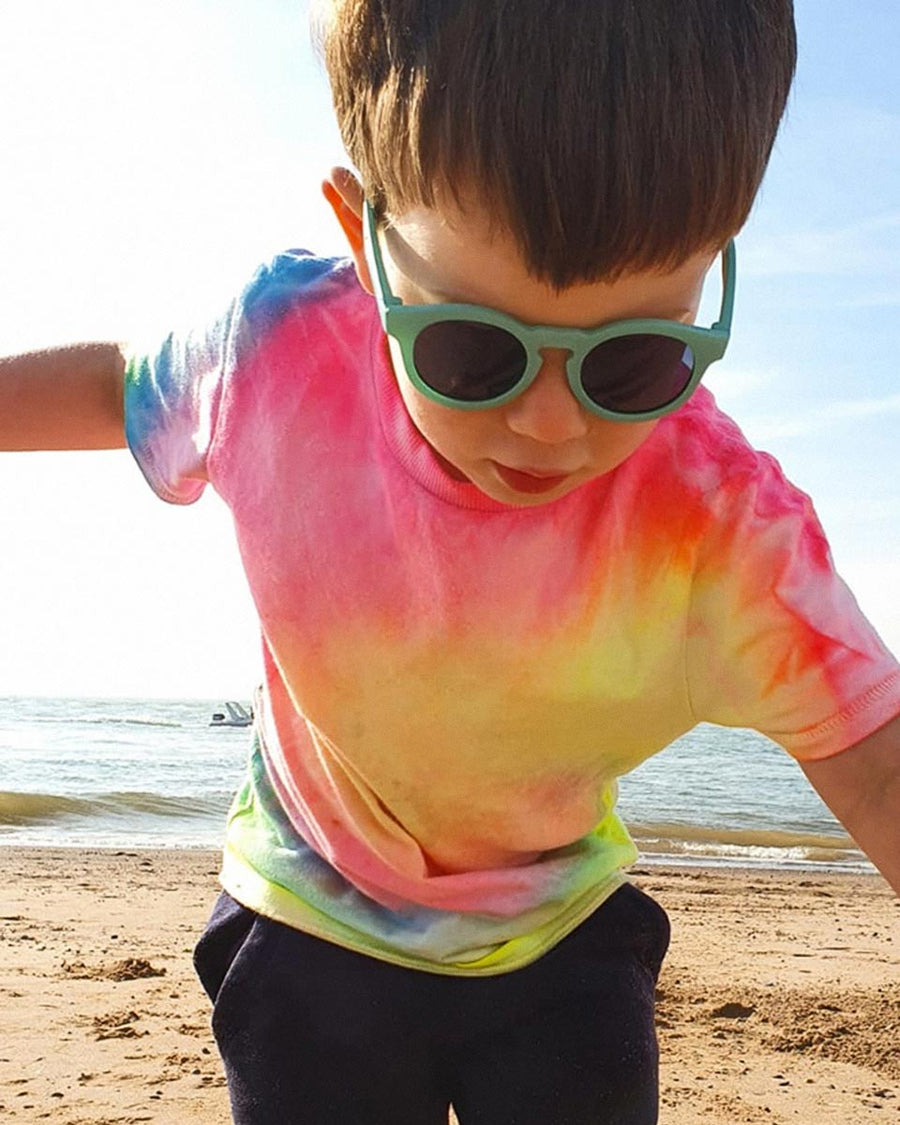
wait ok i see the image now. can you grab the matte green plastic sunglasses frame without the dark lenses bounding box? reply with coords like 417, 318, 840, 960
362, 200, 737, 422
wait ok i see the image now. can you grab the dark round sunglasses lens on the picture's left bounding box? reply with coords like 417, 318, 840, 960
413, 321, 528, 403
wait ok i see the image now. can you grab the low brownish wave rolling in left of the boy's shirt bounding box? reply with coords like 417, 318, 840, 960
0, 791, 228, 828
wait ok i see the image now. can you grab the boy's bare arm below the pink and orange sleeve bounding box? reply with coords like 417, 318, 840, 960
801, 716, 900, 894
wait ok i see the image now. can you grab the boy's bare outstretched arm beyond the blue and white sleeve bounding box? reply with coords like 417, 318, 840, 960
0, 343, 125, 450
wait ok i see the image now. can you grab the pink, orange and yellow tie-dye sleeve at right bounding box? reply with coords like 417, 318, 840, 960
685, 455, 900, 761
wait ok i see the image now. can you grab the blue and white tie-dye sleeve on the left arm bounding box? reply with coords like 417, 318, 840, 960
125, 299, 241, 504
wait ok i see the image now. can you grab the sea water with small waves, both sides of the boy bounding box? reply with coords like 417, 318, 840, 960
0, 699, 873, 871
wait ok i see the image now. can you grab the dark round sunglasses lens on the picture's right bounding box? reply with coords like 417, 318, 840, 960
582, 334, 694, 414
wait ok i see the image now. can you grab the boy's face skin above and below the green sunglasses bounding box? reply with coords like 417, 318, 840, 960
326, 174, 714, 507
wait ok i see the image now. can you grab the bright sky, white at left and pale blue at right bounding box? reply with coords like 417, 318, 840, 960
0, 0, 900, 699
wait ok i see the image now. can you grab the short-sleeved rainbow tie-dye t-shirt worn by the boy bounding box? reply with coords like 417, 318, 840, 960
126, 254, 900, 974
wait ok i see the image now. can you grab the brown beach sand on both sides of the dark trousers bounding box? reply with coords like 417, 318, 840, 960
0, 847, 900, 1125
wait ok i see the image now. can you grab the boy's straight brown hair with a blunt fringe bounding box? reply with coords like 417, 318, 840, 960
320, 0, 797, 288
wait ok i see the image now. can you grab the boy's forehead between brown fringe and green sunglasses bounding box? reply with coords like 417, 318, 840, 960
383, 205, 716, 327
